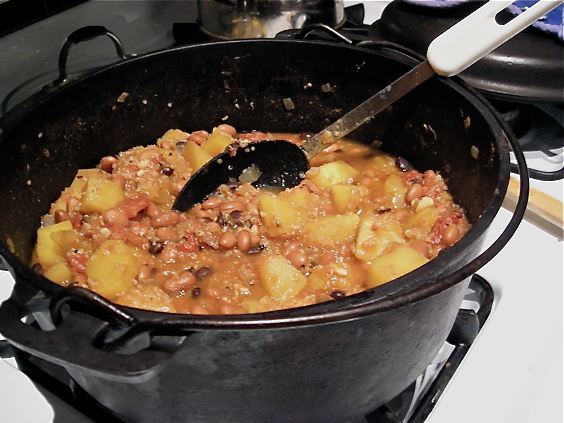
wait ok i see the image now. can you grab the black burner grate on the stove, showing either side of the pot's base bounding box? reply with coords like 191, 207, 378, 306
0, 275, 493, 423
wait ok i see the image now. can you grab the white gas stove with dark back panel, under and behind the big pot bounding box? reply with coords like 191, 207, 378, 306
0, 0, 564, 423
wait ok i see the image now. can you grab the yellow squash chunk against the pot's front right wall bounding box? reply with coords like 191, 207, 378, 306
366, 245, 429, 288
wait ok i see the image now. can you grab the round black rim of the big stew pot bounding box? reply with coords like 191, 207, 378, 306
0, 39, 528, 329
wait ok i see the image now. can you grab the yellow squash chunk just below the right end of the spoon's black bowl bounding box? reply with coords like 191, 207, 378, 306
258, 193, 301, 236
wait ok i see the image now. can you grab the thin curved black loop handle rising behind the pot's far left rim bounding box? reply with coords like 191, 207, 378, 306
44, 25, 128, 89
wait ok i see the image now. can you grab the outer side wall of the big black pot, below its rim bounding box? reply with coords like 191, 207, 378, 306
70, 283, 467, 423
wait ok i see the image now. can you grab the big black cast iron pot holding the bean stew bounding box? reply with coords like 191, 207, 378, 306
0, 28, 528, 423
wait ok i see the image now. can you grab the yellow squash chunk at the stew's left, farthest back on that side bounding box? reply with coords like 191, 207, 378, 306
80, 178, 125, 213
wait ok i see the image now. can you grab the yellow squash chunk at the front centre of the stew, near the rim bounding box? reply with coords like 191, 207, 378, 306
257, 254, 307, 301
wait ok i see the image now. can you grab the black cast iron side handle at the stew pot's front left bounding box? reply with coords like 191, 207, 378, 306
0, 287, 184, 383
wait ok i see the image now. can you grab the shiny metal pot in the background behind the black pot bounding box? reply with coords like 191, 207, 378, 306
198, 0, 345, 40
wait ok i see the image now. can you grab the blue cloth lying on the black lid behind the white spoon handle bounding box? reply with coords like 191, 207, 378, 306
403, 0, 564, 41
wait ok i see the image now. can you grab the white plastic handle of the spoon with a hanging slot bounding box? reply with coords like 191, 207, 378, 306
427, 0, 562, 76
